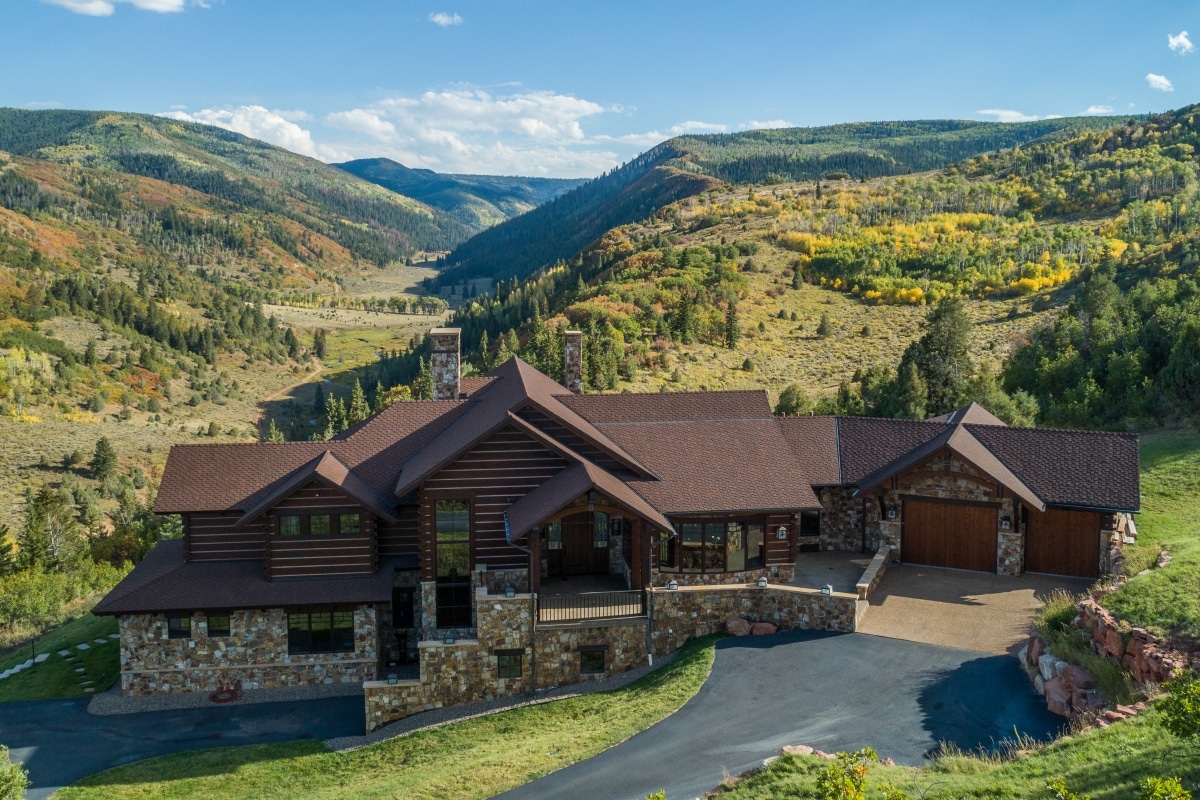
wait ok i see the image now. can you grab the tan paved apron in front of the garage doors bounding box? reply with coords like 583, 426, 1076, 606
858, 564, 1091, 652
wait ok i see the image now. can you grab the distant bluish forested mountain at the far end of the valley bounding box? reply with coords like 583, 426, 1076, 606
334, 158, 587, 233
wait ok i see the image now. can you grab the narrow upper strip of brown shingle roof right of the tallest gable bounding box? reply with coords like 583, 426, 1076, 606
559, 390, 770, 425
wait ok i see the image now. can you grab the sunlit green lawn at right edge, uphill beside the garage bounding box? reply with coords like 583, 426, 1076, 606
1103, 431, 1200, 637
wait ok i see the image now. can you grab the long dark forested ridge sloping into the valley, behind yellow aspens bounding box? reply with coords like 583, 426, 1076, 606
446, 118, 1112, 282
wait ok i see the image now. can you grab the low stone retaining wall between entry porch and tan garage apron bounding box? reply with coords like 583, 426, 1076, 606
647, 584, 859, 655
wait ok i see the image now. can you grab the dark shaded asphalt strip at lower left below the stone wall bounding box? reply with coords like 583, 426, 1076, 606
0, 696, 362, 800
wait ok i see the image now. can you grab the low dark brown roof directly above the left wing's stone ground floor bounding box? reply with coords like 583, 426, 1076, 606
92, 540, 395, 614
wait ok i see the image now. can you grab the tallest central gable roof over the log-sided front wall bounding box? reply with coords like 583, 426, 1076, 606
396, 357, 654, 497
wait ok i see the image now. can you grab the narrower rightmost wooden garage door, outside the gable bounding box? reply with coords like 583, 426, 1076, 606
1025, 509, 1100, 578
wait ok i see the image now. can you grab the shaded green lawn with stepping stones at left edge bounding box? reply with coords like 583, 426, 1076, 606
0, 614, 120, 702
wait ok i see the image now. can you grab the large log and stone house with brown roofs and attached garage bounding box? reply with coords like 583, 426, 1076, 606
95, 329, 1139, 728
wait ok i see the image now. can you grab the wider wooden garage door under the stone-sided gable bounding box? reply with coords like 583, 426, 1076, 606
900, 498, 997, 572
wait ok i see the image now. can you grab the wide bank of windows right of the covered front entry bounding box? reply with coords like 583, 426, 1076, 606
659, 519, 766, 575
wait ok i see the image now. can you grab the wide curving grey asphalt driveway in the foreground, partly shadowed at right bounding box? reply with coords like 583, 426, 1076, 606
499, 631, 1063, 800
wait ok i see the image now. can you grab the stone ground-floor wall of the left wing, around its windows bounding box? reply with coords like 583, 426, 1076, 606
120, 606, 378, 696
